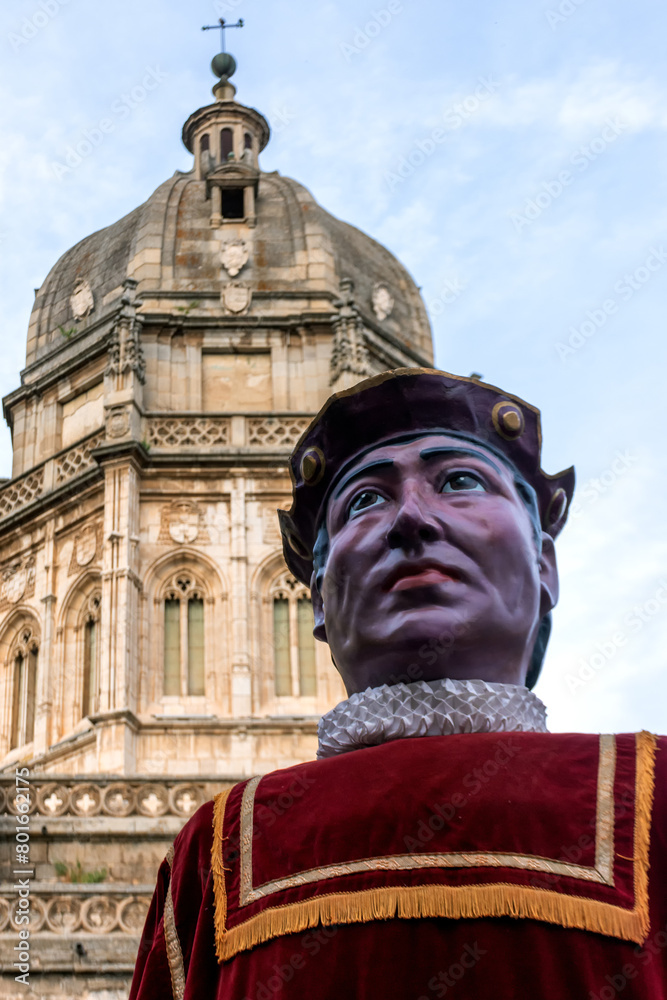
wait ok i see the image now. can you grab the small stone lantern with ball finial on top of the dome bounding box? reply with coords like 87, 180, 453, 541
183, 52, 271, 228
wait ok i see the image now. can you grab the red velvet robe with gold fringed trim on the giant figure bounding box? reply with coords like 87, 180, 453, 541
130, 733, 667, 1000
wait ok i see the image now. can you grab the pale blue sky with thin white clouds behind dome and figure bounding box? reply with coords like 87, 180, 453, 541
0, 0, 667, 732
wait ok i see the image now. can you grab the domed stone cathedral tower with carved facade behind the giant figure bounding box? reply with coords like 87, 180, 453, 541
0, 66, 432, 1000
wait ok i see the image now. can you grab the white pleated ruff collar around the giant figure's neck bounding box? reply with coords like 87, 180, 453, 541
317, 677, 547, 758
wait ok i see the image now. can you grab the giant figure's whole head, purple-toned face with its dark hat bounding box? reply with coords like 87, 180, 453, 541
280, 369, 574, 694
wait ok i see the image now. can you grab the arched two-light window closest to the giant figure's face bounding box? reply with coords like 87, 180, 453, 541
271, 574, 317, 697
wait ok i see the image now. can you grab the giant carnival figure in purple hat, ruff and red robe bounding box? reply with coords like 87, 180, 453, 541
131, 369, 667, 1000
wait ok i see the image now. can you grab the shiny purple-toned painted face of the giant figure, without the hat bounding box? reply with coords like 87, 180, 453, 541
312, 435, 558, 694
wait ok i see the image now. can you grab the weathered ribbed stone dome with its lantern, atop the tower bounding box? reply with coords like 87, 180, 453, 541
27, 95, 432, 377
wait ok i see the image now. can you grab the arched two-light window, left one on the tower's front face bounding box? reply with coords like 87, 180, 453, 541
163, 572, 205, 696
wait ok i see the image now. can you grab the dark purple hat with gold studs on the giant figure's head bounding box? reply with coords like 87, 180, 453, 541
278, 368, 574, 586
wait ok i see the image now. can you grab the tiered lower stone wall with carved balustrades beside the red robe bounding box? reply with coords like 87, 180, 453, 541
0, 775, 225, 1000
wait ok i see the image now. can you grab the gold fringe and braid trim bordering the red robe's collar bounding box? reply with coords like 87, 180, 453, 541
213, 732, 656, 961
